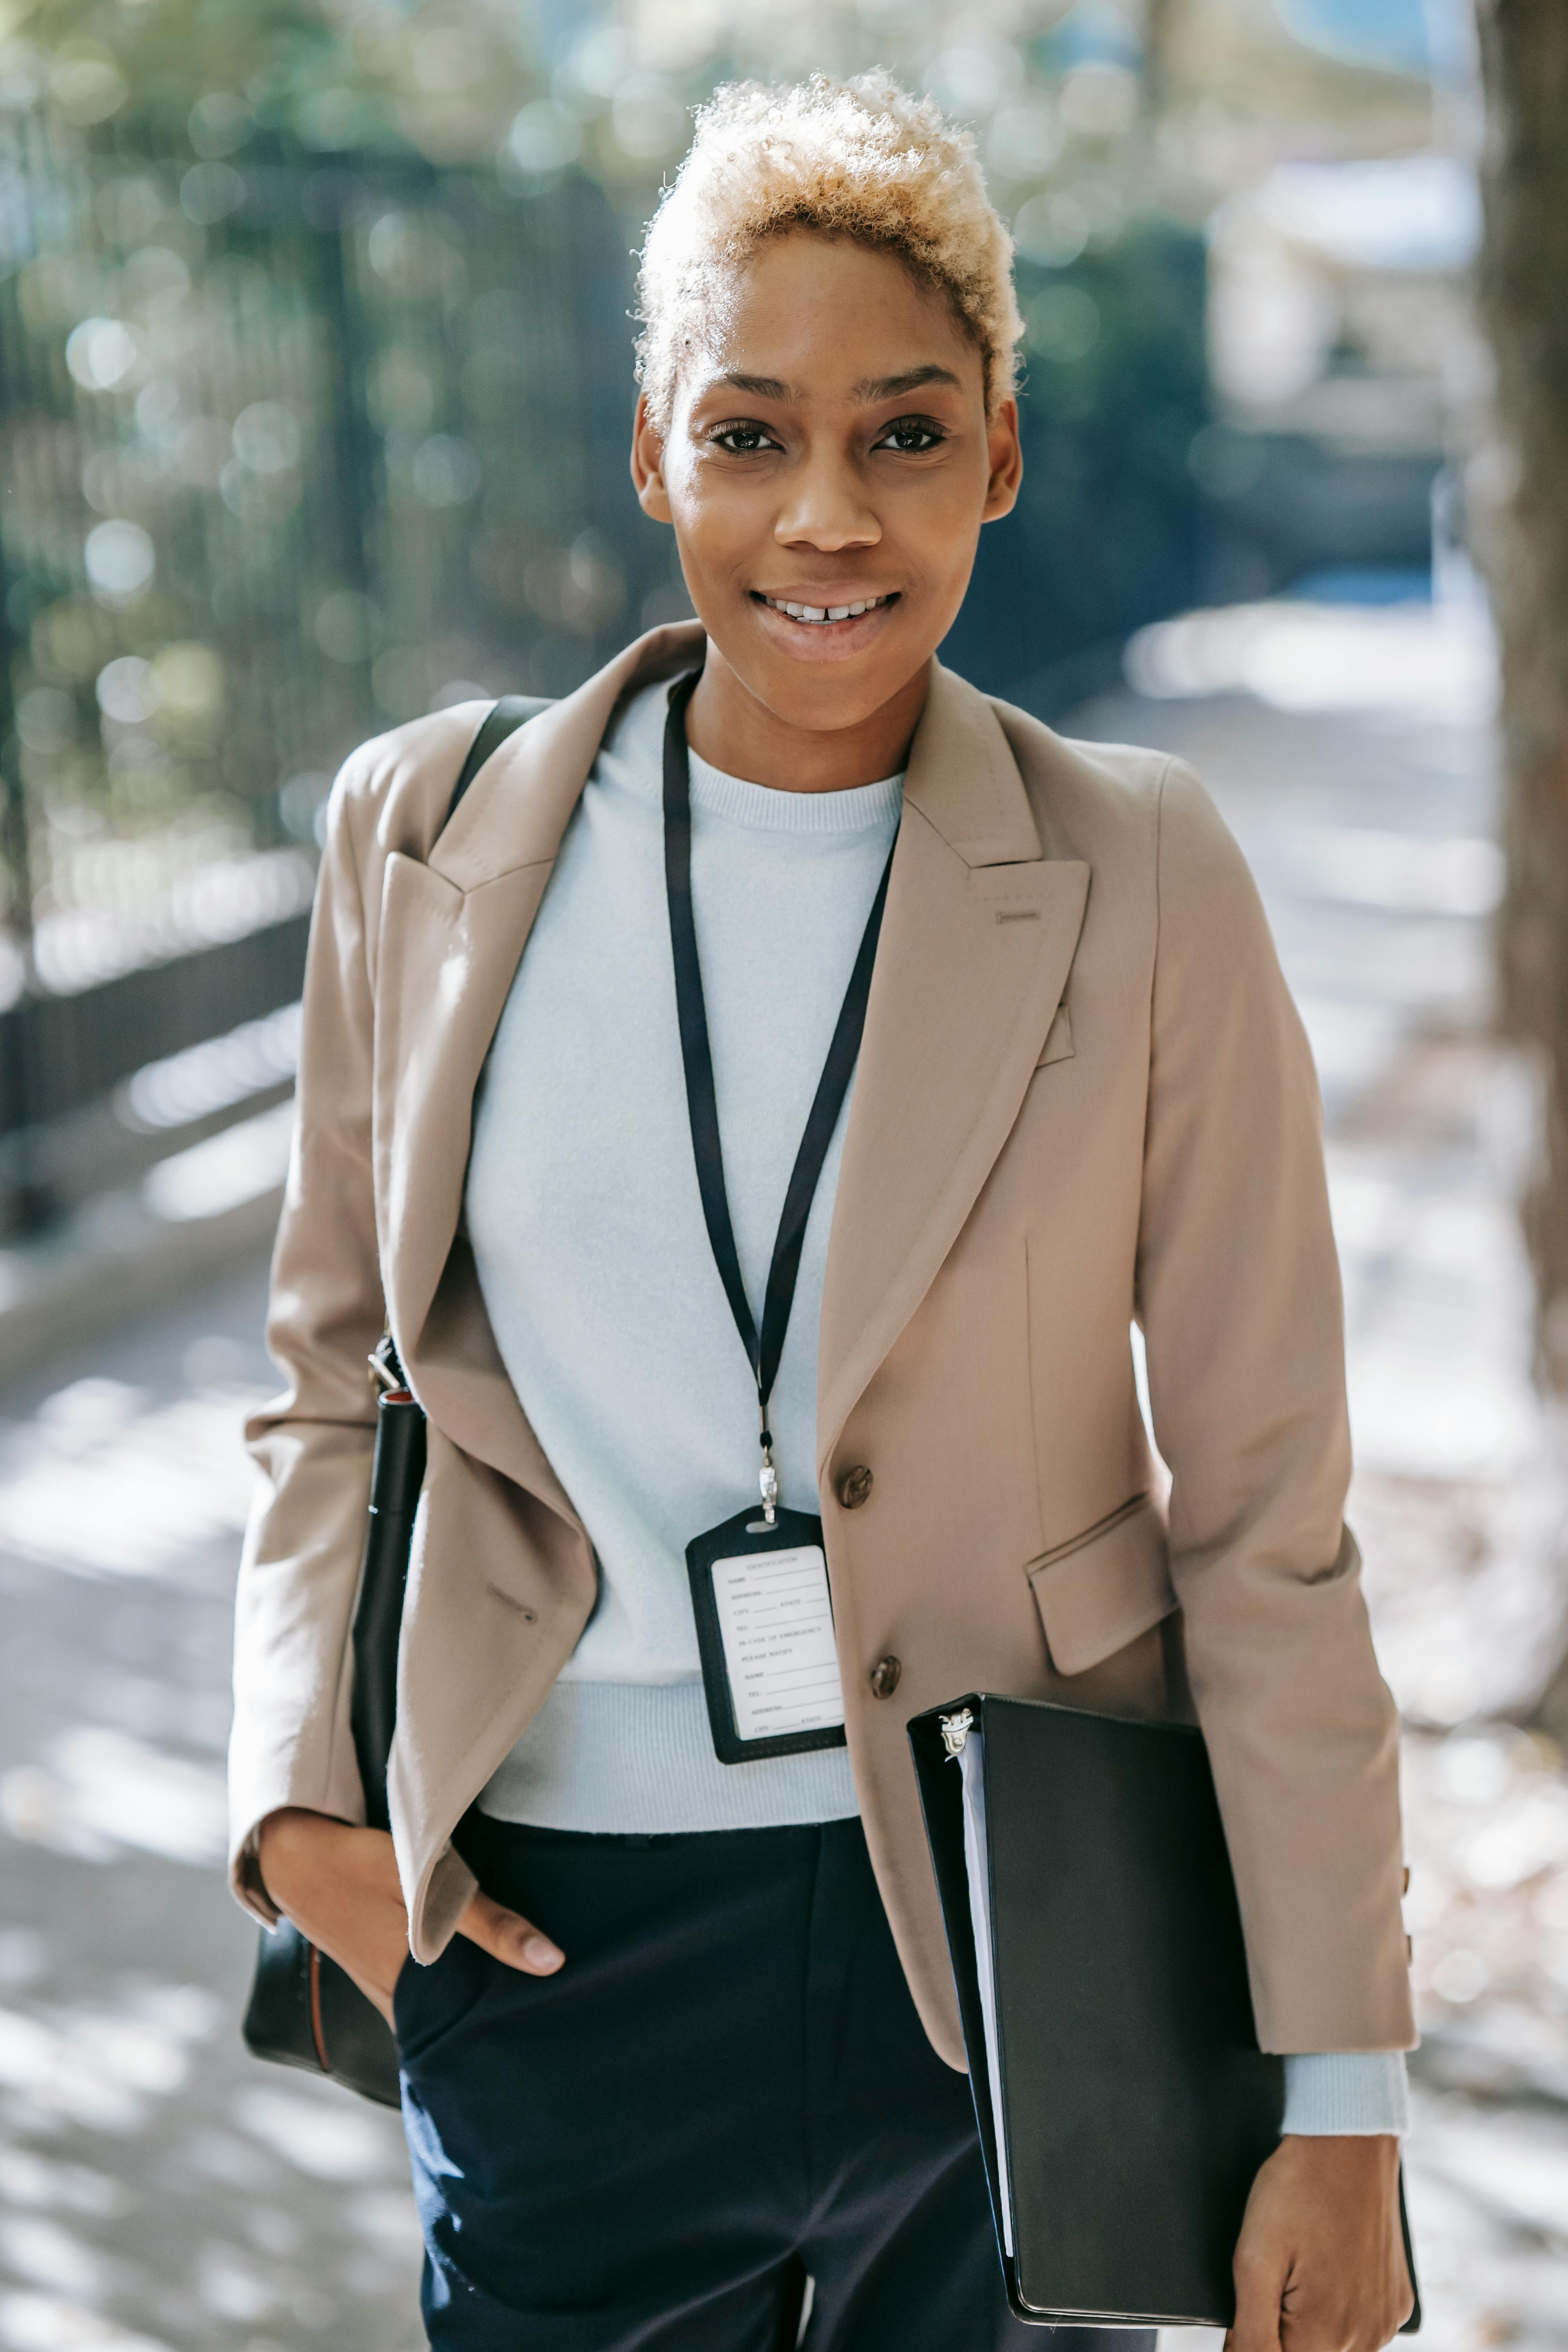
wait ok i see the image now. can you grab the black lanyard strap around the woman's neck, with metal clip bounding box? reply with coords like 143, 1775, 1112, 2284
665, 670, 898, 1527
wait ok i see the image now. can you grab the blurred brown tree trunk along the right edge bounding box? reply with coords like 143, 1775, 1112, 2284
1476, 0, 1568, 1390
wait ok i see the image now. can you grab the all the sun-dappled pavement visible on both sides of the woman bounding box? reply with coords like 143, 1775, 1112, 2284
0, 607, 1568, 2352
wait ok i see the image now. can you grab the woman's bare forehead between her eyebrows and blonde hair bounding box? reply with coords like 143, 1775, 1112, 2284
682, 230, 983, 400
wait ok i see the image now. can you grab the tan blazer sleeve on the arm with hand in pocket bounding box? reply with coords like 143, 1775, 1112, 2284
228, 745, 383, 1921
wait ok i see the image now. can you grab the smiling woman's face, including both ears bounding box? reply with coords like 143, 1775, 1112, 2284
632, 233, 1023, 732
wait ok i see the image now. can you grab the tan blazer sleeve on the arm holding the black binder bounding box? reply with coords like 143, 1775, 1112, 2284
1138, 762, 1415, 2051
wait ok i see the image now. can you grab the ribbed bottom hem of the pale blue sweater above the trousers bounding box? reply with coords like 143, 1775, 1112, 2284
480, 1682, 860, 1837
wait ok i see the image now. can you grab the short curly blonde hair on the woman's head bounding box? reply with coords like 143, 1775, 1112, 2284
637, 71, 1023, 433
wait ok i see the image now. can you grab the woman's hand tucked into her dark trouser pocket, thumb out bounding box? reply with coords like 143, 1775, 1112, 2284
256, 1806, 566, 2025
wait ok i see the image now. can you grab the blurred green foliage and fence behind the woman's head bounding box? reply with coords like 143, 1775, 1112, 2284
0, 0, 1204, 964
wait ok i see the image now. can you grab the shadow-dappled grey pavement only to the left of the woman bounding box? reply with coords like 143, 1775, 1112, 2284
0, 1254, 423, 2352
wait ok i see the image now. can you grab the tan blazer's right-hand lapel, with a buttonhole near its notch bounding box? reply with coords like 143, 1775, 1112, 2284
818, 666, 1088, 1463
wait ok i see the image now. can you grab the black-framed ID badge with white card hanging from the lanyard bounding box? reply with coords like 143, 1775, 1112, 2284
686, 1503, 846, 1764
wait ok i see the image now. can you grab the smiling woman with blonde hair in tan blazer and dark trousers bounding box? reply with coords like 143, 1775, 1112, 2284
233, 78, 1411, 2352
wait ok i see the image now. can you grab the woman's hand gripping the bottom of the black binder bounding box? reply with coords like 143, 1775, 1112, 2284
1225, 2133, 1415, 2352
